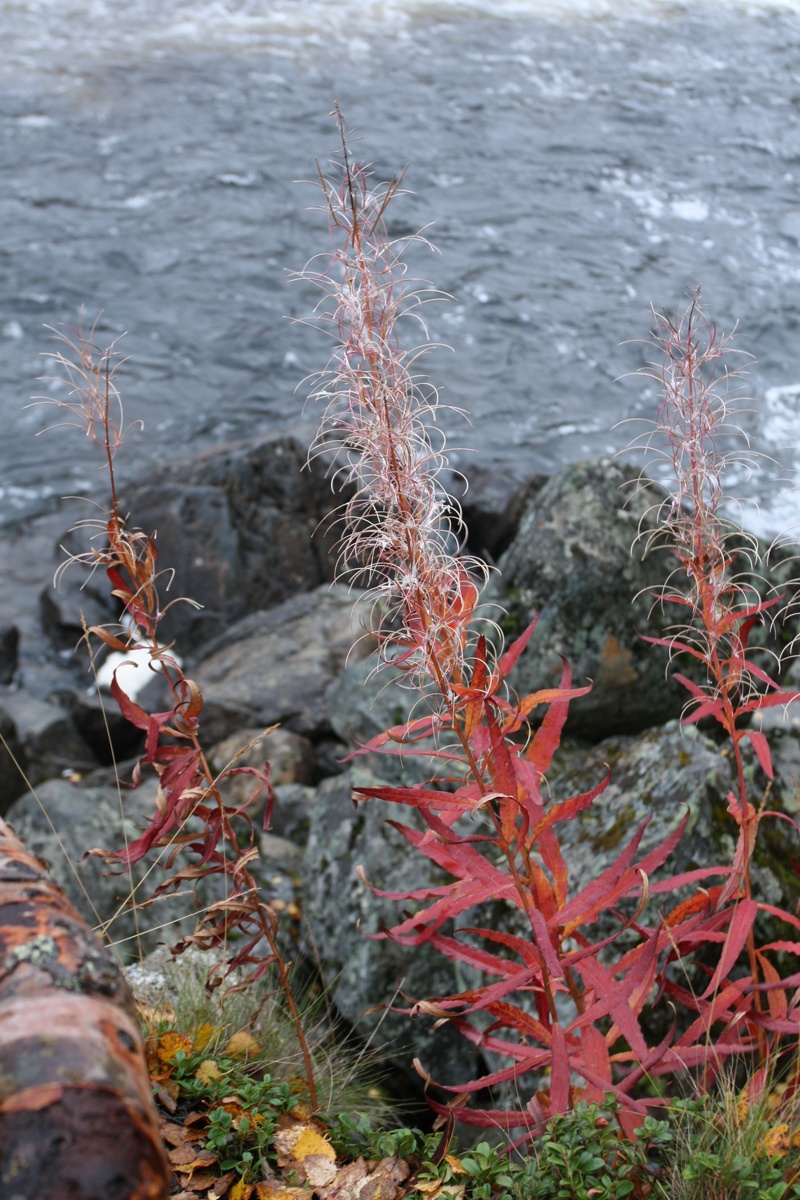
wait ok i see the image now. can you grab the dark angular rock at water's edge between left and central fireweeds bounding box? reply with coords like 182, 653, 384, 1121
118, 437, 339, 648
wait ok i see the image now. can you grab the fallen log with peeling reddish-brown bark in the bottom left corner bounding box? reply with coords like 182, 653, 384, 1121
0, 820, 169, 1200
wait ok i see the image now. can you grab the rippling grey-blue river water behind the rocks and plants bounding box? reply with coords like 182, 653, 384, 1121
0, 0, 800, 528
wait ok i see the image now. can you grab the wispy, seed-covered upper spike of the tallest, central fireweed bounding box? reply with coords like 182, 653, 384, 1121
300, 108, 486, 698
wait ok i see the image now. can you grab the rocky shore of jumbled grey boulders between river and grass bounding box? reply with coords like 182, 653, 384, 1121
0, 438, 800, 1099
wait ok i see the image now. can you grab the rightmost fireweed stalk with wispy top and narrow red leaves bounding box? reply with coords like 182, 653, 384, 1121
634, 293, 795, 1060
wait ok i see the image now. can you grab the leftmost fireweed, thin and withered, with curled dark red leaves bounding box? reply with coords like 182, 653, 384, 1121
37, 330, 317, 1109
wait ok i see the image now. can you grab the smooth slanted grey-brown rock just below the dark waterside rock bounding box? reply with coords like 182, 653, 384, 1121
194, 587, 374, 742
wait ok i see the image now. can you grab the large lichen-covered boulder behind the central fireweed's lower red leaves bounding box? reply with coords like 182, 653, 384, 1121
298, 721, 800, 1099
